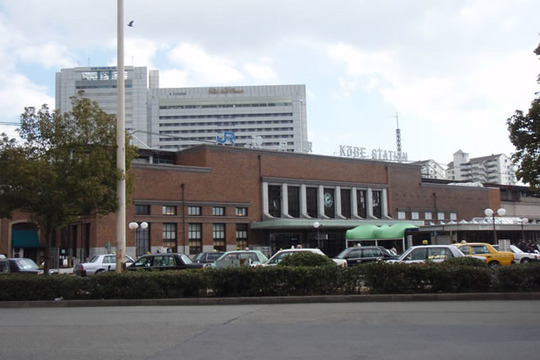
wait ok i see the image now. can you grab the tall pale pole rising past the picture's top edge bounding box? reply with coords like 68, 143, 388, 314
116, 0, 126, 272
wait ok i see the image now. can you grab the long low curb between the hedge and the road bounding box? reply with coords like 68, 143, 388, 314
0, 292, 540, 309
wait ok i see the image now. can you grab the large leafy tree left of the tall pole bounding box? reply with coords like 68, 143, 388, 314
0, 92, 136, 272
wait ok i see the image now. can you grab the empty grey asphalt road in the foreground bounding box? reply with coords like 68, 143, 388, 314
0, 300, 540, 360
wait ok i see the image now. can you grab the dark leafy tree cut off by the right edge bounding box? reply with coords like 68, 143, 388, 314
507, 44, 540, 190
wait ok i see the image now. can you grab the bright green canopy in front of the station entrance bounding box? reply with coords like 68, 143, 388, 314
345, 223, 418, 249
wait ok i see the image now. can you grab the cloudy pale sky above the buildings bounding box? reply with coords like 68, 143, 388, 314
0, 0, 540, 164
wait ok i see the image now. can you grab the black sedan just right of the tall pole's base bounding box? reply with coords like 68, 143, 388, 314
127, 253, 204, 271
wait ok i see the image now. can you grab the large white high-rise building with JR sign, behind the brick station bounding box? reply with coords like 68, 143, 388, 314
56, 66, 311, 152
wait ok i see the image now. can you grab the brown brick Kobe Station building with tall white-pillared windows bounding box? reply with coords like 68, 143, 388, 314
0, 145, 520, 260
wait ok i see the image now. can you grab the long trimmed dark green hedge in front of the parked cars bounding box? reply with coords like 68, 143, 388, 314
0, 262, 540, 301
